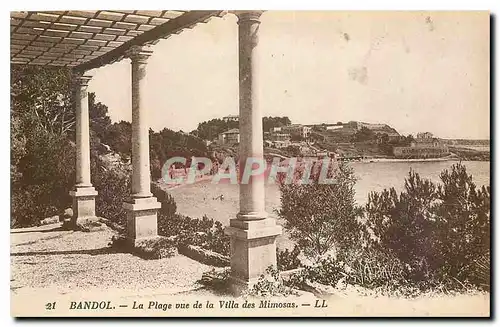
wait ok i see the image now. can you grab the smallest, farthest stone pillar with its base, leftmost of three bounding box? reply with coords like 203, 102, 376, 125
70, 74, 97, 227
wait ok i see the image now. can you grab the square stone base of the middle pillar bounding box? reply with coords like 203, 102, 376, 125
123, 197, 161, 246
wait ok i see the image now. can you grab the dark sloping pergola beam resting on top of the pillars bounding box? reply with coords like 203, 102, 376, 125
74, 11, 222, 72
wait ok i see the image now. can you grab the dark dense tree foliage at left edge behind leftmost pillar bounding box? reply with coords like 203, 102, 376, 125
11, 65, 118, 227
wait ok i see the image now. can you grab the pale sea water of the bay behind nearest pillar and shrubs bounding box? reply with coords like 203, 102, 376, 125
169, 161, 490, 224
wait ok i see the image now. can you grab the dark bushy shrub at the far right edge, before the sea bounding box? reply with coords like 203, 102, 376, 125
435, 164, 490, 280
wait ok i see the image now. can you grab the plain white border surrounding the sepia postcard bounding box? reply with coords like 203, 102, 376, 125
0, 0, 500, 326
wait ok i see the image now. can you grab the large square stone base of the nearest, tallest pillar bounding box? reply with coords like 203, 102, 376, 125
225, 218, 282, 294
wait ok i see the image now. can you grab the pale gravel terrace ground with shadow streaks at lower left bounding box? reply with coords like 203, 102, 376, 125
11, 224, 215, 294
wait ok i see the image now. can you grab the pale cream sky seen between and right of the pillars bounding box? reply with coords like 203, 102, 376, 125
89, 11, 490, 139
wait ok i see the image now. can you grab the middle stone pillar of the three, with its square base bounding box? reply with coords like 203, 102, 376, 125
123, 46, 161, 246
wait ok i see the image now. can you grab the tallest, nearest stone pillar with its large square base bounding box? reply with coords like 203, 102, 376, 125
225, 11, 281, 293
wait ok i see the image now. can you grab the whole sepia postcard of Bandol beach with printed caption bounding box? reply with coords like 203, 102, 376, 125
10, 9, 491, 317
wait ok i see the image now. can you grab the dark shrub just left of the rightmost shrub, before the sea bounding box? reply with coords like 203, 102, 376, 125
365, 171, 438, 281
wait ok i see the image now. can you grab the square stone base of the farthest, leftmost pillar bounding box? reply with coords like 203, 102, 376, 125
69, 186, 98, 227
